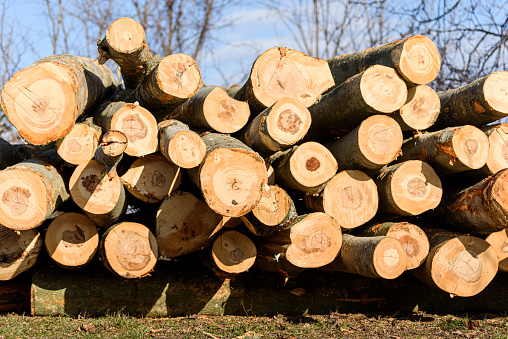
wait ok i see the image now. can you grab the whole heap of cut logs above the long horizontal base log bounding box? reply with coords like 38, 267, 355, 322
0, 18, 508, 314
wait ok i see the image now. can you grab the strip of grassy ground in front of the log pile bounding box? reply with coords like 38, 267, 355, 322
0, 313, 508, 339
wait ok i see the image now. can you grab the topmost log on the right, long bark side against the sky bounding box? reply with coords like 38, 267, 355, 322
328, 35, 441, 86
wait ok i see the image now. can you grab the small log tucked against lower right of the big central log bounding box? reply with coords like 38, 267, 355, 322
240, 186, 298, 236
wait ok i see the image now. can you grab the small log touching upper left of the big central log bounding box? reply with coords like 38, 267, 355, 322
158, 119, 206, 168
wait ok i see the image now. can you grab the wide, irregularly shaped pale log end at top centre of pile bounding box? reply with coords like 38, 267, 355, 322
235, 47, 334, 113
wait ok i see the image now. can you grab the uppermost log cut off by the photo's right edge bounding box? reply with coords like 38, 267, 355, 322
432, 71, 508, 130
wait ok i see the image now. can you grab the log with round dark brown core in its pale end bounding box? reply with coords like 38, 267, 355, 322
268, 142, 338, 193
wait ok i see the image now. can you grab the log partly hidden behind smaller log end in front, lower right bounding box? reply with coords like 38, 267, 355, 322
354, 221, 429, 271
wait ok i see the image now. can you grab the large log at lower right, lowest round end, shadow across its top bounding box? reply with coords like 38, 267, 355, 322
411, 229, 498, 297
